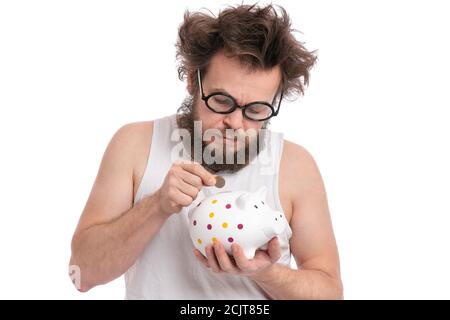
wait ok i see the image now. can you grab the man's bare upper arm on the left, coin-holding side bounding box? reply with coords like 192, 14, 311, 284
72, 123, 152, 232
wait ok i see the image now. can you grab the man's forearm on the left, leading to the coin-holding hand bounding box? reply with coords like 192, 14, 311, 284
70, 191, 167, 291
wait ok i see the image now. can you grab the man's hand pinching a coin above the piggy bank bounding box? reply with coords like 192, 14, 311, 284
157, 161, 216, 215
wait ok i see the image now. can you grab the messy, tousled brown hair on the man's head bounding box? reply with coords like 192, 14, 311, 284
176, 4, 317, 98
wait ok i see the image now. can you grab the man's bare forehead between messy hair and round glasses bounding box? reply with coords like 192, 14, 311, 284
205, 51, 281, 96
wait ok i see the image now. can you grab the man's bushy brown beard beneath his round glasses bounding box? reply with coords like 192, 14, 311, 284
177, 96, 269, 173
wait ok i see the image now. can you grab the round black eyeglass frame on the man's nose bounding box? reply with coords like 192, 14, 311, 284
197, 69, 283, 121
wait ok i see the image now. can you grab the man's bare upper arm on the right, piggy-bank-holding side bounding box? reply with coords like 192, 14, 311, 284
283, 142, 340, 279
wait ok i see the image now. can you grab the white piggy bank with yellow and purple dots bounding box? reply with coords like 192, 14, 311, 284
188, 187, 287, 259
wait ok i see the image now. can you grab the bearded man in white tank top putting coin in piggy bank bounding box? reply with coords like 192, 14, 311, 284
70, 5, 343, 299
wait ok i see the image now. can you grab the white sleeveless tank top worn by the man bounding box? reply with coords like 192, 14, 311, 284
125, 115, 292, 300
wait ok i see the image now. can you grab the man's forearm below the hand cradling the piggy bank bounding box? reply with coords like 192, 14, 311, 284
251, 264, 343, 300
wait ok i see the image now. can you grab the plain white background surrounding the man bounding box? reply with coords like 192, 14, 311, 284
0, 0, 450, 299
